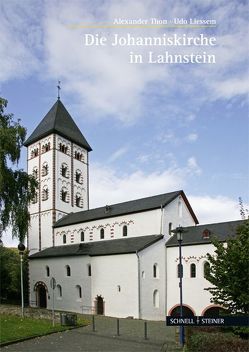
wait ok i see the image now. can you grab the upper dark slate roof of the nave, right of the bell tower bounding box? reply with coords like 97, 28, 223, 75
54, 191, 198, 228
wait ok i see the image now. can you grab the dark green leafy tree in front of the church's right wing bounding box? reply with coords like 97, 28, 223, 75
206, 220, 249, 314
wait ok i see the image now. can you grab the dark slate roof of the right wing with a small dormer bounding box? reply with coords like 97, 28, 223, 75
166, 220, 243, 247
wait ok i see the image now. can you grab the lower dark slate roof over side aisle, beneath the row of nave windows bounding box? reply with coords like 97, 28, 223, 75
29, 235, 163, 259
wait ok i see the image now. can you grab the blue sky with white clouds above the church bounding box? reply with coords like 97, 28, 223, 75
0, 0, 249, 245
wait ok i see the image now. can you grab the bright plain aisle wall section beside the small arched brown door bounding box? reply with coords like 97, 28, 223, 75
91, 254, 138, 318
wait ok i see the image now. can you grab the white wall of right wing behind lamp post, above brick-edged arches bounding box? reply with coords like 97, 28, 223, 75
167, 244, 214, 315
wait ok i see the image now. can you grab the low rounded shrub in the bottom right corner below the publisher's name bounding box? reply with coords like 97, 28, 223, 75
187, 333, 249, 352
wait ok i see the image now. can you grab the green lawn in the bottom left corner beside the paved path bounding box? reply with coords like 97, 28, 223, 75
0, 314, 88, 343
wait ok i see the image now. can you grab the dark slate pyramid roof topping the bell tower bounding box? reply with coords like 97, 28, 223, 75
24, 99, 92, 151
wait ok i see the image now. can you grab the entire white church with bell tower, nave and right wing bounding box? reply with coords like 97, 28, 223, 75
25, 99, 243, 320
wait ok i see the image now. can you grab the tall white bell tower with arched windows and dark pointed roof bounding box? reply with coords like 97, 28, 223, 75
24, 98, 92, 254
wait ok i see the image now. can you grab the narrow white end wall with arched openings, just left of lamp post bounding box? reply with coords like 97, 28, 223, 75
139, 239, 166, 320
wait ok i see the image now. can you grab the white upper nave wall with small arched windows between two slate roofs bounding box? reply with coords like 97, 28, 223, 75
54, 209, 161, 245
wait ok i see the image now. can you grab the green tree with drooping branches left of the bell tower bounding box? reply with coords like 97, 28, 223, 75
0, 98, 37, 242
